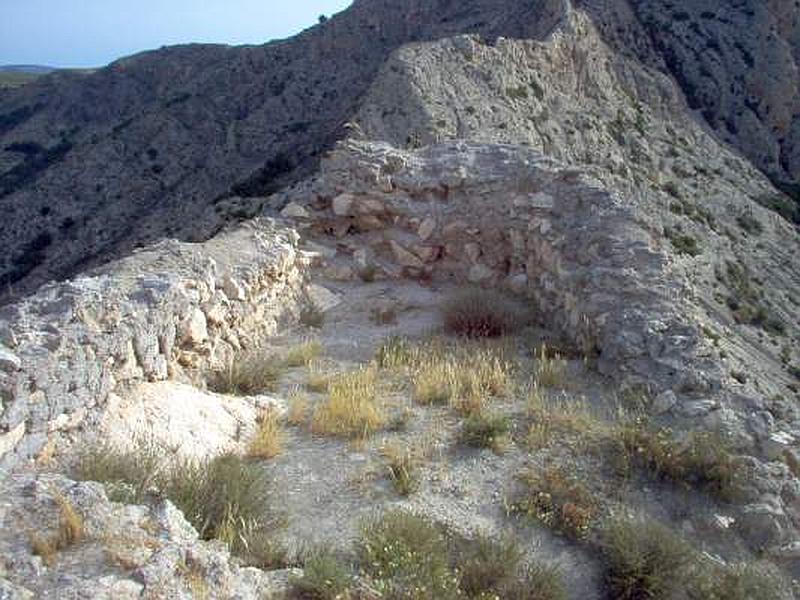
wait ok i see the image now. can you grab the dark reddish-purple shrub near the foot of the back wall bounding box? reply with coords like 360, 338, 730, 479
442, 289, 521, 338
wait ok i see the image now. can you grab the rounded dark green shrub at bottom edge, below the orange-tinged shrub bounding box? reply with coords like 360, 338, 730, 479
599, 518, 694, 600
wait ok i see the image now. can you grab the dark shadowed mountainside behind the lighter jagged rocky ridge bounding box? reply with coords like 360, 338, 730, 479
0, 0, 800, 294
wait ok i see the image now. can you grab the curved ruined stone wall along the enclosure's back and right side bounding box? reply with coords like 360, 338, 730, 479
284, 142, 719, 389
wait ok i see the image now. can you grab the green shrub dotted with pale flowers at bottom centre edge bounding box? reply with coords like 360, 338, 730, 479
357, 511, 459, 600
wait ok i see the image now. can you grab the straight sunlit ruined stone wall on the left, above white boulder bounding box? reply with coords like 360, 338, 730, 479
0, 220, 304, 469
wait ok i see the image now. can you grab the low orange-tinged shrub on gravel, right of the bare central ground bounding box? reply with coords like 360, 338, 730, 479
511, 466, 597, 538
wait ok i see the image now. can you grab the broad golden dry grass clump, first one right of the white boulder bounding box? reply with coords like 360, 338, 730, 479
312, 367, 386, 439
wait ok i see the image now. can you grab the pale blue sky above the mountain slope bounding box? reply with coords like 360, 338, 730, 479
0, 0, 351, 67
